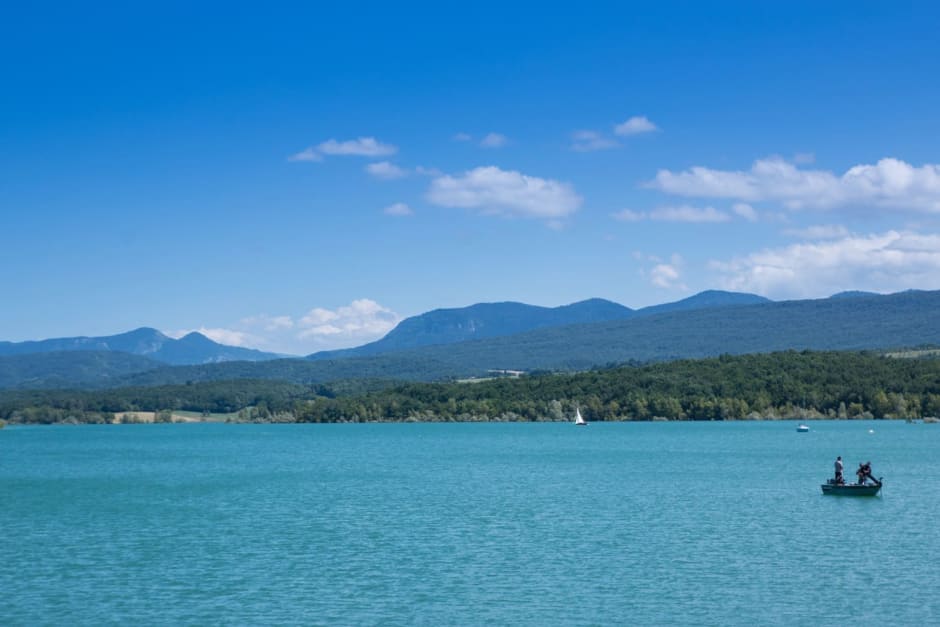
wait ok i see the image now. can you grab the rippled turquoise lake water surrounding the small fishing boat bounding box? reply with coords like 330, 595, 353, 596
0, 421, 940, 625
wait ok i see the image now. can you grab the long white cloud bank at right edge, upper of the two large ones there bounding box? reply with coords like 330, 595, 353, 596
648, 158, 940, 213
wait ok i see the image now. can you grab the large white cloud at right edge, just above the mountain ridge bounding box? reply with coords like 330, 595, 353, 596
710, 231, 940, 298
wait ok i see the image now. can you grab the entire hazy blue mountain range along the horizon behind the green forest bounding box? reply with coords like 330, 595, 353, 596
0, 291, 940, 388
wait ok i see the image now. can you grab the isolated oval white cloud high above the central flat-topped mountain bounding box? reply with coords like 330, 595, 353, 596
427, 166, 581, 219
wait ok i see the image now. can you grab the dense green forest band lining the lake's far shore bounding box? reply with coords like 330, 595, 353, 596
0, 351, 940, 423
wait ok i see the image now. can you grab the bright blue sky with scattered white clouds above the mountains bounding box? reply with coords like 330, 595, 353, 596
0, 2, 940, 354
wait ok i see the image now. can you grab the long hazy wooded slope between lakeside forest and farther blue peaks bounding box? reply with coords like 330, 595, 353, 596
5, 291, 940, 387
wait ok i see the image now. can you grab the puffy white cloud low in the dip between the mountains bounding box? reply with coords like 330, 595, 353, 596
298, 298, 401, 345
